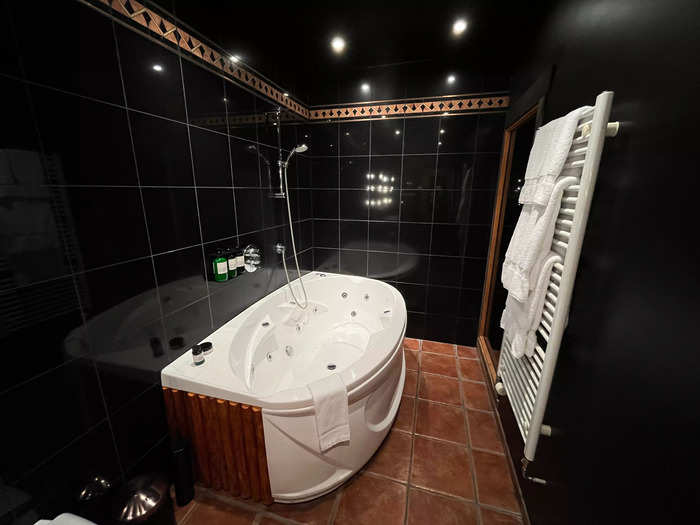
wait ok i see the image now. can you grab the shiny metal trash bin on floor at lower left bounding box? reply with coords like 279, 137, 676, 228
114, 474, 175, 525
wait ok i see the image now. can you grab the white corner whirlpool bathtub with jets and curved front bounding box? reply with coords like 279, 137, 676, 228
161, 272, 406, 503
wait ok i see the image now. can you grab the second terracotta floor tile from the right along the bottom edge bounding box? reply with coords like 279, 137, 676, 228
406, 488, 479, 525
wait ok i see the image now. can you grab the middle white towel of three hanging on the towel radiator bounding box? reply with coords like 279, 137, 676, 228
501, 177, 578, 302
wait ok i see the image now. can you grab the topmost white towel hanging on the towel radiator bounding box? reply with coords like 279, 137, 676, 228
518, 106, 592, 206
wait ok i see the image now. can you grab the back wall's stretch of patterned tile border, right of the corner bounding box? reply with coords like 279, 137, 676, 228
309, 95, 510, 120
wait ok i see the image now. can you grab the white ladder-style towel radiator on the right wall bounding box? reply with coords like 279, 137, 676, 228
496, 91, 619, 478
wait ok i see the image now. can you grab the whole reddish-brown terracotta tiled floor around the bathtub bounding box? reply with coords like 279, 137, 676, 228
177, 339, 522, 525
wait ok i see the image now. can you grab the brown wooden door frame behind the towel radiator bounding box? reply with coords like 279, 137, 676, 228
476, 99, 543, 384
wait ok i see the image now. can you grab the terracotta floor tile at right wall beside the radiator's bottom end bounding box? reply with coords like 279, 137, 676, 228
472, 450, 520, 512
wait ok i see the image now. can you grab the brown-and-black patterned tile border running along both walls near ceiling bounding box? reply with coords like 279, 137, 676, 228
85, 0, 510, 121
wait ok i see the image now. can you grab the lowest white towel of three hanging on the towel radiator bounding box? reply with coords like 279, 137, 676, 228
501, 252, 562, 358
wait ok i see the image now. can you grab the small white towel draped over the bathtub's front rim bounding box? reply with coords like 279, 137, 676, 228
309, 374, 350, 452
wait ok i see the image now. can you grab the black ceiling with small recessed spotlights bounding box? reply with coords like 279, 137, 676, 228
148, 0, 550, 105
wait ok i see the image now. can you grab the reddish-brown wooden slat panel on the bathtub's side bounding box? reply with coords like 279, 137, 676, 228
163, 387, 272, 504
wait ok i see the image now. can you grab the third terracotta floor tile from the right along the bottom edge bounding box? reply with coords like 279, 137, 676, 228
334, 474, 406, 525
